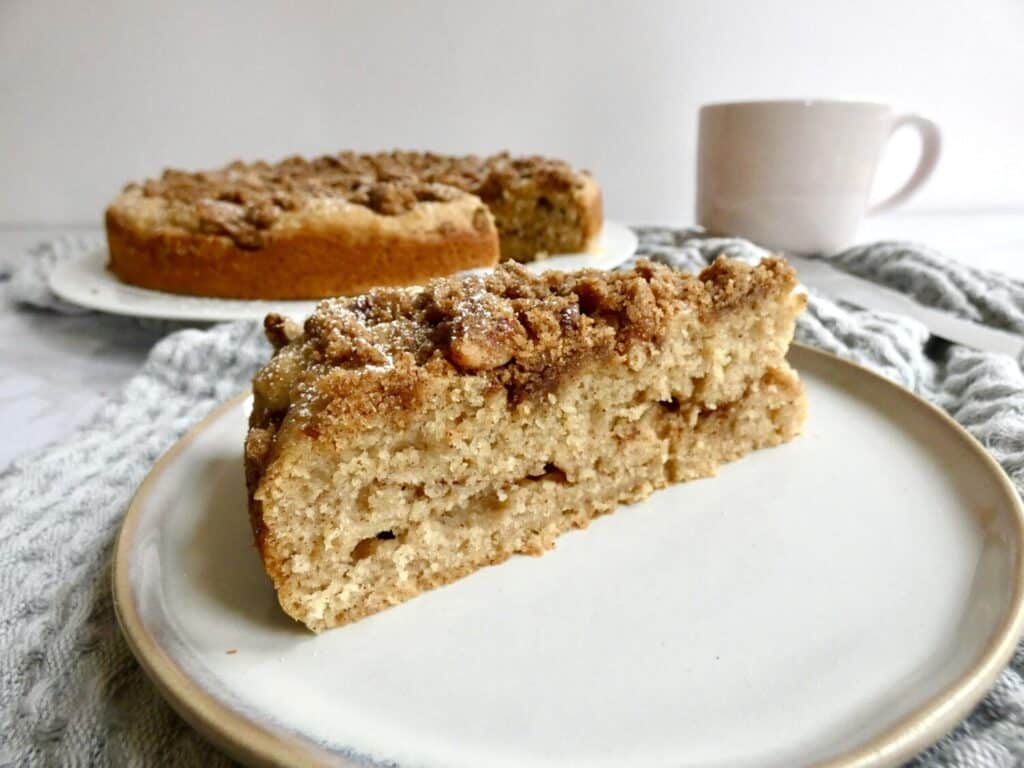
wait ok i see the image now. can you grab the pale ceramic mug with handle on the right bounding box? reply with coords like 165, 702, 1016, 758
697, 100, 941, 253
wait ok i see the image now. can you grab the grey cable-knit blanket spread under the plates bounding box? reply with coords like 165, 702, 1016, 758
0, 228, 1024, 768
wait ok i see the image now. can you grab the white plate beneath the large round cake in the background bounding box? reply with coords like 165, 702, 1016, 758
50, 221, 637, 323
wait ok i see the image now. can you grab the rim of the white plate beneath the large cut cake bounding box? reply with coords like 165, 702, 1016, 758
46, 220, 639, 323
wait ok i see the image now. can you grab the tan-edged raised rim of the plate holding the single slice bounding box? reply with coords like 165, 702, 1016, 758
112, 342, 1024, 768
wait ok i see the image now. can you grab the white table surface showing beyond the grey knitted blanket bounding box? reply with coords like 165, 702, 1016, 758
0, 210, 1024, 469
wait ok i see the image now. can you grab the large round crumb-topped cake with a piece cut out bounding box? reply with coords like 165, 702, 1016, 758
105, 152, 601, 299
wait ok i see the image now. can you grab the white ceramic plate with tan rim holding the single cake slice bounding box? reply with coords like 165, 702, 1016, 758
114, 348, 1022, 768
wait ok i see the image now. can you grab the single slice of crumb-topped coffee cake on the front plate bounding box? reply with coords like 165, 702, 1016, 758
246, 259, 805, 632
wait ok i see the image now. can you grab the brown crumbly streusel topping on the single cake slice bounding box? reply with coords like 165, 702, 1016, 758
258, 259, 796, 409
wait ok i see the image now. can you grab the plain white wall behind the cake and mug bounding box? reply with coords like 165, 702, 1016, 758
0, 0, 1024, 224
